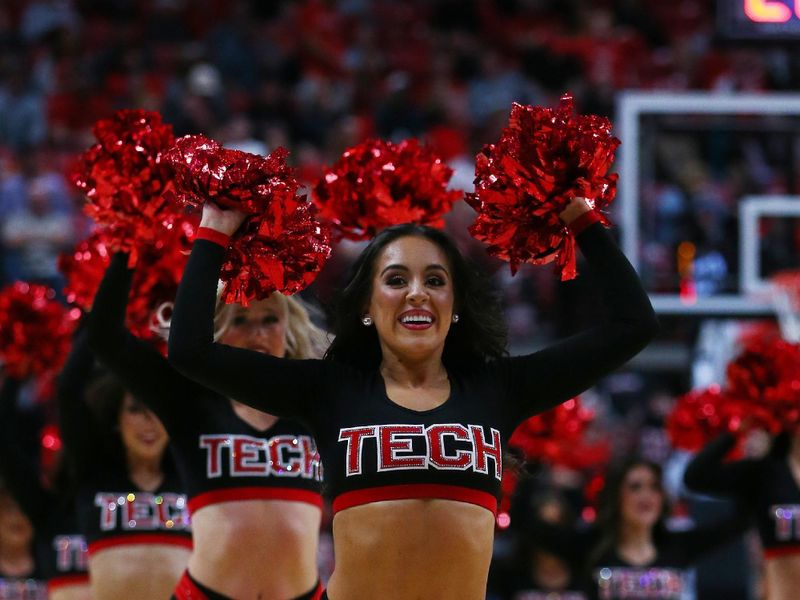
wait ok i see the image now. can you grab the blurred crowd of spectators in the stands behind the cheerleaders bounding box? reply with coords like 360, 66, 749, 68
0, 0, 800, 598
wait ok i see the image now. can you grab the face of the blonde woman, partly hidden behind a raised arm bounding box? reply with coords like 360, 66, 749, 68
219, 294, 288, 358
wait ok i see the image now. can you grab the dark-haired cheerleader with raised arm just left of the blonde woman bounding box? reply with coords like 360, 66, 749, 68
58, 331, 192, 600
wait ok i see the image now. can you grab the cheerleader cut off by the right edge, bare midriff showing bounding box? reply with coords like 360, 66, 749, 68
684, 432, 800, 600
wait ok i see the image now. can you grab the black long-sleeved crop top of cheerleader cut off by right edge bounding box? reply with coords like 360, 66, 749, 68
684, 433, 800, 558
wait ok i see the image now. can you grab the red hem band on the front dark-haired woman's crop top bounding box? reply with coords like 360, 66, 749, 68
333, 483, 497, 516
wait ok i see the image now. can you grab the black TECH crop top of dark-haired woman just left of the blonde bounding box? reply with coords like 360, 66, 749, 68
58, 331, 192, 555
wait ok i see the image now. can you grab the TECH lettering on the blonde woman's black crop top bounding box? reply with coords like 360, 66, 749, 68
200, 434, 322, 481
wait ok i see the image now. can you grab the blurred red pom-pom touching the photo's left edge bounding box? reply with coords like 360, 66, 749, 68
0, 281, 80, 378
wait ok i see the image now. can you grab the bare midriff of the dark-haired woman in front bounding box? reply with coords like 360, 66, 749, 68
328, 499, 494, 600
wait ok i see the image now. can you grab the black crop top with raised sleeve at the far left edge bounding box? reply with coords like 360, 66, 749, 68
0, 378, 89, 588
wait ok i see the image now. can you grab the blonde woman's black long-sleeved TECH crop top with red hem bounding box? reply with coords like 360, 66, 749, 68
89, 254, 322, 512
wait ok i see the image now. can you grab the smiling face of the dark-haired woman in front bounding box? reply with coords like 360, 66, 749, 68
365, 236, 455, 360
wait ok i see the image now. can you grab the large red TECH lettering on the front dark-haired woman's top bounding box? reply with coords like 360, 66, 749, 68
339, 423, 503, 481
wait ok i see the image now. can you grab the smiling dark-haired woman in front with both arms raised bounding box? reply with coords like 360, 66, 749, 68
169, 199, 657, 600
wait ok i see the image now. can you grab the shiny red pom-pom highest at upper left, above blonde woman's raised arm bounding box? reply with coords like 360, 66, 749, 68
70, 110, 182, 264
